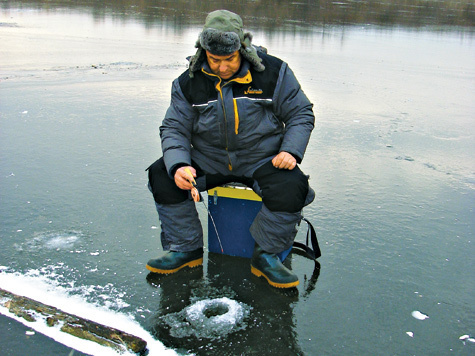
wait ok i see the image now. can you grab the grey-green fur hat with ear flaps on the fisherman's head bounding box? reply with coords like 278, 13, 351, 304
189, 10, 265, 78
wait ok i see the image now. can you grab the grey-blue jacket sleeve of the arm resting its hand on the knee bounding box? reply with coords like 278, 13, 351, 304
273, 62, 315, 163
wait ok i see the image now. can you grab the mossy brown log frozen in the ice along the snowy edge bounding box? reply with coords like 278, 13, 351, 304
0, 288, 147, 354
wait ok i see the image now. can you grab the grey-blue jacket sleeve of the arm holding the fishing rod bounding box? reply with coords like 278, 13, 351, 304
160, 79, 196, 178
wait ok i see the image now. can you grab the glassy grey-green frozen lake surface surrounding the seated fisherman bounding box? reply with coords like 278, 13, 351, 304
0, 1, 475, 355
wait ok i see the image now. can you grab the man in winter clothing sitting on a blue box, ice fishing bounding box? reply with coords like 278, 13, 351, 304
147, 10, 315, 288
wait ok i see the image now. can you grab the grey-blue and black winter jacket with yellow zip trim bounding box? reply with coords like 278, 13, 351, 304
160, 53, 315, 177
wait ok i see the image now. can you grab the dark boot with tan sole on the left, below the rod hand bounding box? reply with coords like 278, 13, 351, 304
146, 248, 203, 274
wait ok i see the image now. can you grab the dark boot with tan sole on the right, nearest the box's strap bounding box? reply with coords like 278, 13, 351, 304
251, 244, 299, 288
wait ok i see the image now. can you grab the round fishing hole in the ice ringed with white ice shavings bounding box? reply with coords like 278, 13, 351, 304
161, 297, 251, 339
